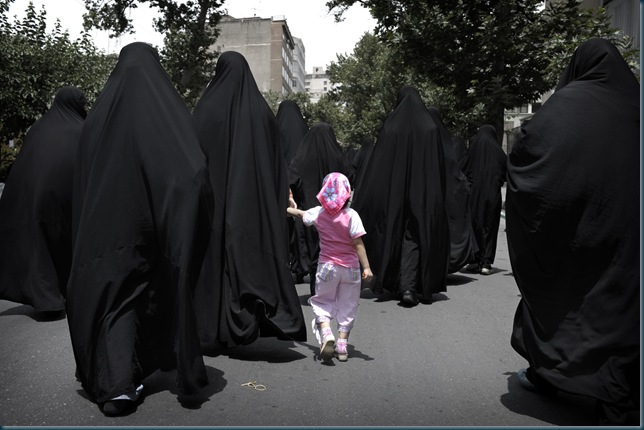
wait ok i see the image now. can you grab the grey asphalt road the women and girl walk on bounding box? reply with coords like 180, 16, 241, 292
0, 215, 594, 427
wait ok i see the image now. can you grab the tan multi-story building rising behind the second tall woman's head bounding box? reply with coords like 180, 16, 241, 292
213, 16, 305, 94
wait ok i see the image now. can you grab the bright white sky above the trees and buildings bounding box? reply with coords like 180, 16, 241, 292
9, 0, 376, 72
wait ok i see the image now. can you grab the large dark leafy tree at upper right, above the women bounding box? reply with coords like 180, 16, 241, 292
327, 0, 640, 139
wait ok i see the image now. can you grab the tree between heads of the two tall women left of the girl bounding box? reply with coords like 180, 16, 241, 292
83, 0, 224, 107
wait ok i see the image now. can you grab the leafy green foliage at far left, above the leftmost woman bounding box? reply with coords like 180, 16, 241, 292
0, 0, 115, 181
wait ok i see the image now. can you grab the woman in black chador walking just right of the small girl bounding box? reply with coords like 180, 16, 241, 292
352, 86, 450, 306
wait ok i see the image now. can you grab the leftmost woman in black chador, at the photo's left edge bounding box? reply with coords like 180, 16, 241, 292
0, 87, 87, 316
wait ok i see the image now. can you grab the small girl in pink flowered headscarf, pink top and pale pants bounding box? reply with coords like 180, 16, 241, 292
286, 172, 373, 361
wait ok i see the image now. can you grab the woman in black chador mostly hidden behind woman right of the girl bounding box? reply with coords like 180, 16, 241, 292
427, 107, 478, 273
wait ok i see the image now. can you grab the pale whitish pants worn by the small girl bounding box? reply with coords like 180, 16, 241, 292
309, 263, 361, 333
